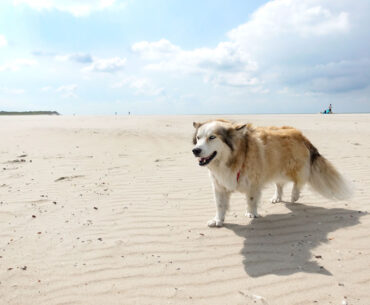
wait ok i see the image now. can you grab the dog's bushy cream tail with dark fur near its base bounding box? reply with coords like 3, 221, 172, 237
308, 143, 353, 200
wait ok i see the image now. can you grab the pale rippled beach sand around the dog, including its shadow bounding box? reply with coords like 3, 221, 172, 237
0, 114, 370, 305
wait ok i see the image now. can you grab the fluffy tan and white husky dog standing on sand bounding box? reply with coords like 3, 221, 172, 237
193, 120, 352, 227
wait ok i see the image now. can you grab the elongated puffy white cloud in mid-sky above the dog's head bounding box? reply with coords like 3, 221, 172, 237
132, 39, 258, 86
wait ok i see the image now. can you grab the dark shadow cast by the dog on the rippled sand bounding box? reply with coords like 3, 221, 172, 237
225, 203, 364, 277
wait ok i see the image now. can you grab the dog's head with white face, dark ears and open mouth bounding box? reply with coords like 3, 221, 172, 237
193, 120, 246, 166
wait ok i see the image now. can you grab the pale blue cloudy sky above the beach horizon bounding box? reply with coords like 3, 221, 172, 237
0, 0, 370, 115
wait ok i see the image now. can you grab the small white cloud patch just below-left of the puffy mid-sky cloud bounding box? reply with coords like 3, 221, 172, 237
112, 77, 164, 96
